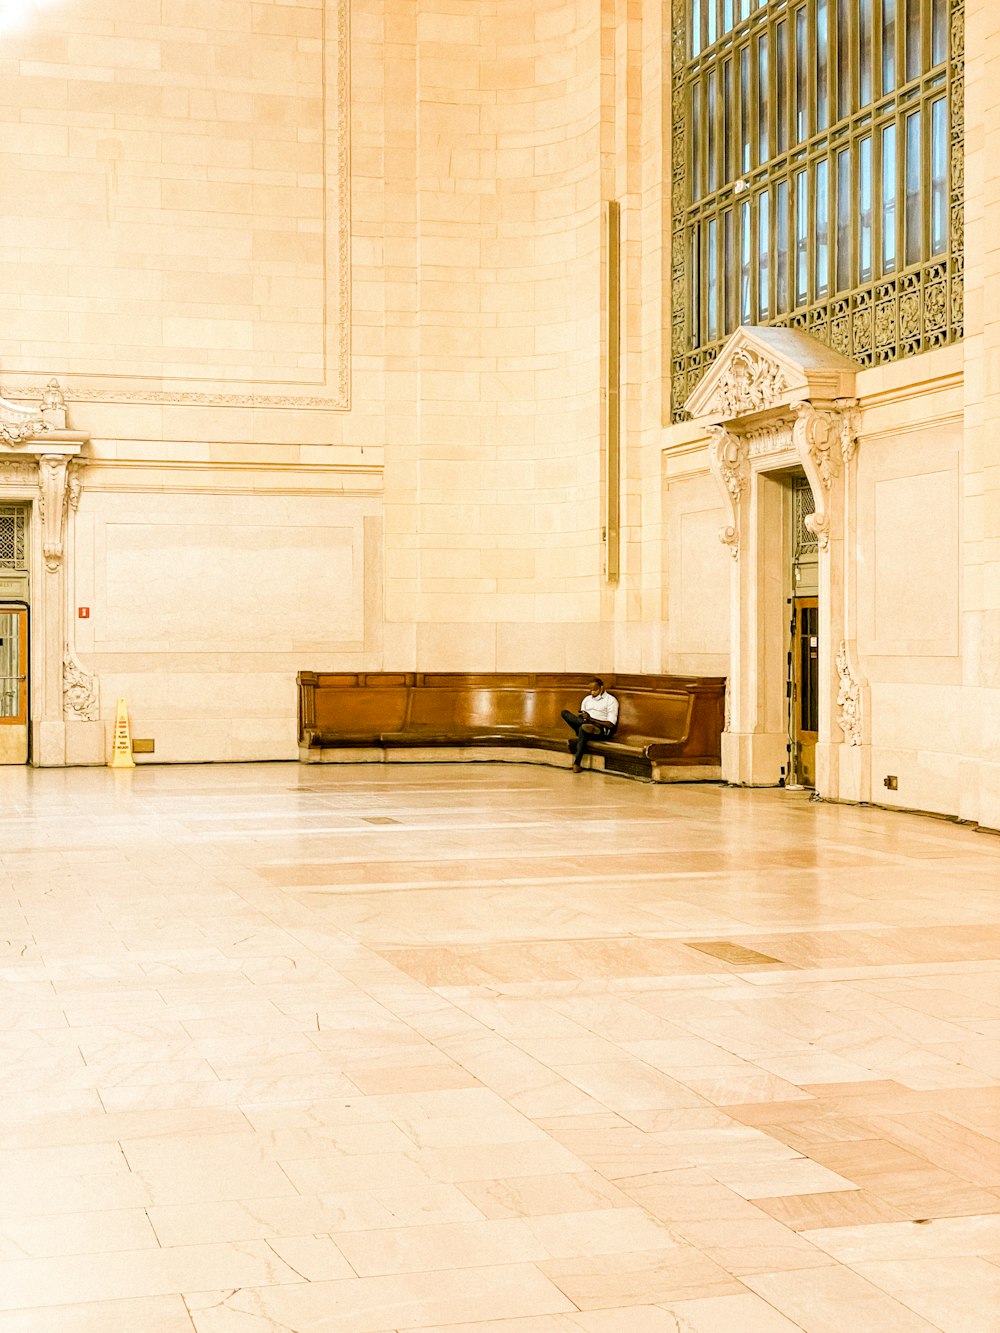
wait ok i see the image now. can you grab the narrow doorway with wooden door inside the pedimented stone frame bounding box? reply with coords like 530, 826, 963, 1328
787, 473, 820, 788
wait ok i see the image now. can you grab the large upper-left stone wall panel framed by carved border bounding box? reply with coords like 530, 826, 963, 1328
0, 0, 347, 395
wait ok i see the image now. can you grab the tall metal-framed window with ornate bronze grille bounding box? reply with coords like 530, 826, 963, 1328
671, 0, 964, 413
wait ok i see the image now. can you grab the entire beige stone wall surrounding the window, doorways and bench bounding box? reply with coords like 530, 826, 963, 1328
0, 0, 1000, 810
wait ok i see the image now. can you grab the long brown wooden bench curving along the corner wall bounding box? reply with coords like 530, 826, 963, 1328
299, 672, 725, 782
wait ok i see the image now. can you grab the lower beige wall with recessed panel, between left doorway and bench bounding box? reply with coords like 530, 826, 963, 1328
67, 467, 381, 762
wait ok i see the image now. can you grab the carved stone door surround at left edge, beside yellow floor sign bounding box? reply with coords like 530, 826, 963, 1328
0, 380, 97, 768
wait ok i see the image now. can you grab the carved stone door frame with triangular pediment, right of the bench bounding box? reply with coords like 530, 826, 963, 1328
687, 328, 871, 801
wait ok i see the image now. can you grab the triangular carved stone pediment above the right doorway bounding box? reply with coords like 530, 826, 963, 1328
685, 327, 859, 424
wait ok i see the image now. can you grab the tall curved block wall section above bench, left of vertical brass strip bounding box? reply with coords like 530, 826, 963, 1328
376, 0, 612, 669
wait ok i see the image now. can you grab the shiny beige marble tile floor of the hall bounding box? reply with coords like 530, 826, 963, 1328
0, 764, 1000, 1333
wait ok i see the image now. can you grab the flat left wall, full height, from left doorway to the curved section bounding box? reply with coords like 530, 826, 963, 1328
0, 0, 385, 761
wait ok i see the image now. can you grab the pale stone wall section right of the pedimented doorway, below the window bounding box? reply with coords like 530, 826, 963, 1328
855, 347, 983, 820
